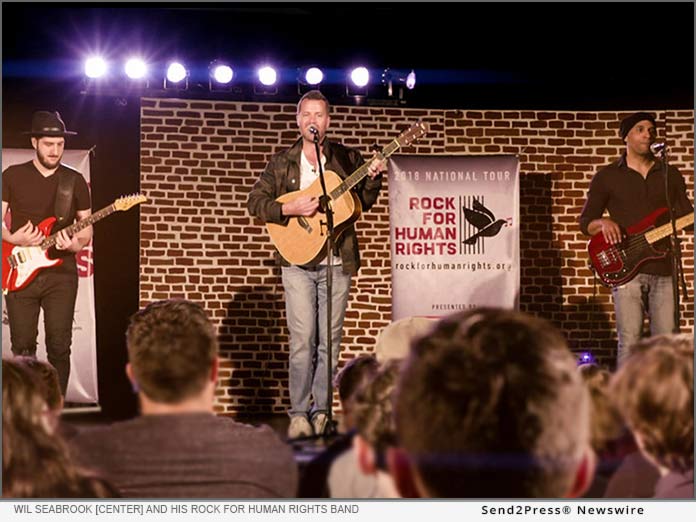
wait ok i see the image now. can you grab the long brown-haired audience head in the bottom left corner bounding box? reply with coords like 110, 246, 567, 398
2, 359, 118, 498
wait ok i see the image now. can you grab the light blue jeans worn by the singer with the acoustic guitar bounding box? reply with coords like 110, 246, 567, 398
282, 265, 351, 416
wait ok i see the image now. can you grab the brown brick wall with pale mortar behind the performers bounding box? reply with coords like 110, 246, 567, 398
140, 99, 694, 414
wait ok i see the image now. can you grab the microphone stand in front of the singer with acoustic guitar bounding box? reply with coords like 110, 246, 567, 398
312, 132, 336, 437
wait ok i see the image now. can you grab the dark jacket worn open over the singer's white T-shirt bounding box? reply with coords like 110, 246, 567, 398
247, 138, 382, 274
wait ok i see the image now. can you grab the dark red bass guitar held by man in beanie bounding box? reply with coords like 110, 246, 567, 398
587, 208, 694, 287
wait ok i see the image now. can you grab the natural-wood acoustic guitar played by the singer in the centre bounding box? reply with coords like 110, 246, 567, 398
266, 122, 428, 265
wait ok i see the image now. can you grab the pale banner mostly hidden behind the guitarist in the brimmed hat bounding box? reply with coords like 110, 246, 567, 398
2, 149, 98, 404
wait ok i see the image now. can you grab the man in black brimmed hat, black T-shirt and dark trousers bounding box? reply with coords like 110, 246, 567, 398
2, 111, 92, 395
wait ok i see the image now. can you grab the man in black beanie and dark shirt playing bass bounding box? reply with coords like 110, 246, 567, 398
580, 112, 693, 365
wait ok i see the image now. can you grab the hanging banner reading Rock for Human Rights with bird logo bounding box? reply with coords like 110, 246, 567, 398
389, 155, 520, 321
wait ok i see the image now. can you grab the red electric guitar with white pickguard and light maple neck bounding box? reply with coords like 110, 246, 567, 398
2, 194, 147, 294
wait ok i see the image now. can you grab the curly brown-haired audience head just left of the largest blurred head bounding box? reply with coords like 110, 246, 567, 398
353, 359, 402, 473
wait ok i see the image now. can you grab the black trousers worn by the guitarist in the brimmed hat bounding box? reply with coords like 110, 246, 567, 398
5, 268, 77, 396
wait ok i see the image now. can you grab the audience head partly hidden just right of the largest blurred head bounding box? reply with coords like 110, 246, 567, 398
578, 363, 625, 452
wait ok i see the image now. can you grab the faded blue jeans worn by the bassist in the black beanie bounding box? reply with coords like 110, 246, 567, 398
612, 274, 674, 366
